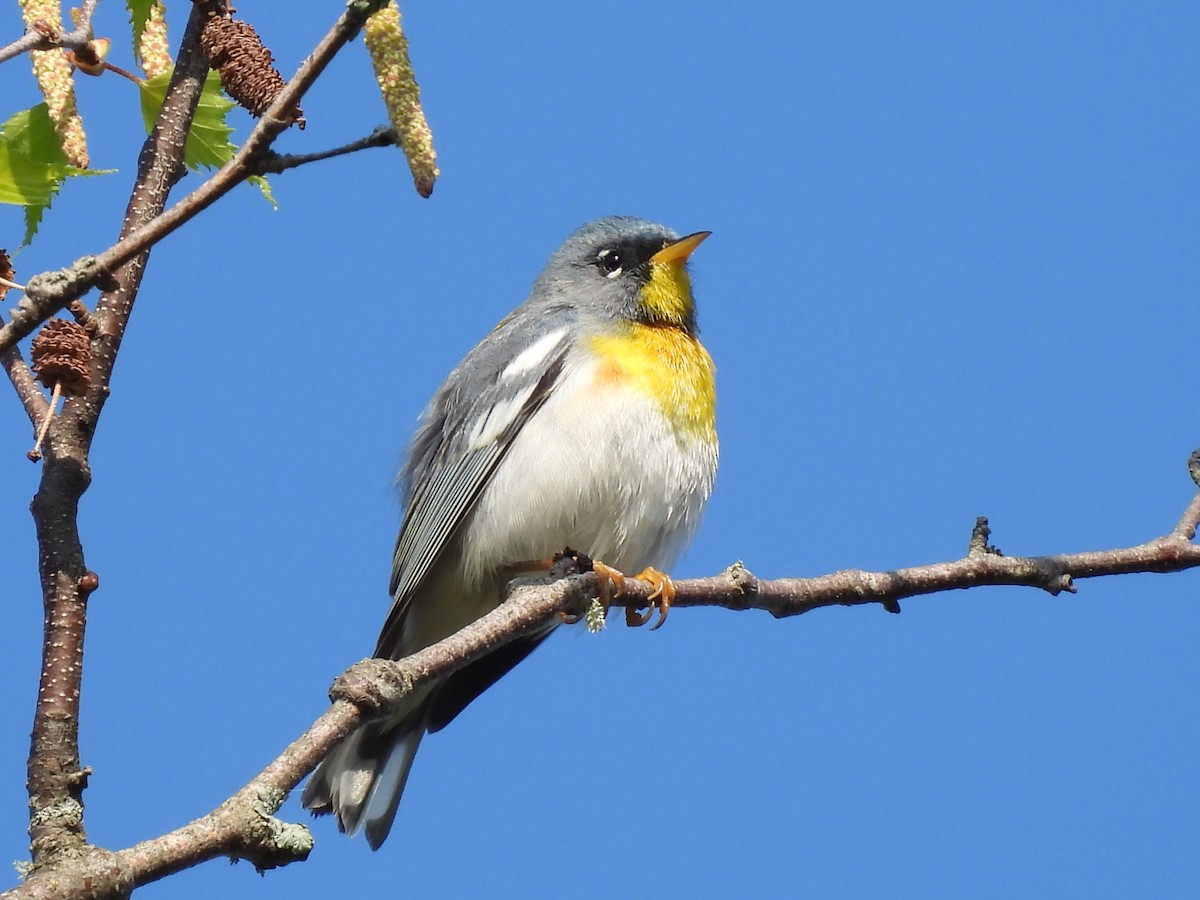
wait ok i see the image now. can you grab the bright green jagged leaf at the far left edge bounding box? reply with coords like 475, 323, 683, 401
0, 103, 113, 246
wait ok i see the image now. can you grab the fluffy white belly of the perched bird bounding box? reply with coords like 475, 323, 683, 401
462, 359, 716, 588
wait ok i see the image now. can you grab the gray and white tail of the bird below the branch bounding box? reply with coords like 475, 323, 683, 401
301, 703, 428, 850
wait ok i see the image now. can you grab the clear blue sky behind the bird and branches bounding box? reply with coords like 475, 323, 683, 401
0, 0, 1200, 900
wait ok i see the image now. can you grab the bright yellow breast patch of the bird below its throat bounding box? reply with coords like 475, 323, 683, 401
590, 322, 716, 442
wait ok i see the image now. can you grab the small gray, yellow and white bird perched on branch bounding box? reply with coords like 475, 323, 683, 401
302, 216, 718, 850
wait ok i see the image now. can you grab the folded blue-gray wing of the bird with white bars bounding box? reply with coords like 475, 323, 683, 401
376, 311, 568, 656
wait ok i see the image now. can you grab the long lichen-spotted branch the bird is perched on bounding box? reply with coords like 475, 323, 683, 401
6, 472, 1200, 900
